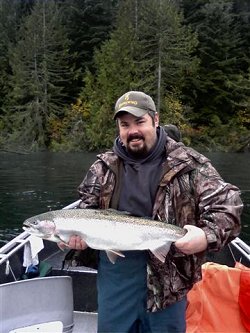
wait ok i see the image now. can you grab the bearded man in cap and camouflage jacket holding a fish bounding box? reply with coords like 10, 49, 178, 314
66, 91, 242, 333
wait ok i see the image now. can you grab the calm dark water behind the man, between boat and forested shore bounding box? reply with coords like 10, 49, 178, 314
0, 153, 250, 244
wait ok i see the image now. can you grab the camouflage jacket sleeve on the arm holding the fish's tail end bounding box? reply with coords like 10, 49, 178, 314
191, 162, 243, 251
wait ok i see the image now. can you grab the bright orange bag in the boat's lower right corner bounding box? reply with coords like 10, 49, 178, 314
186, 262, 250, 333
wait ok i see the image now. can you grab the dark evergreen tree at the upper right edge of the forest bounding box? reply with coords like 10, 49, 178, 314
183, 0, 249, 125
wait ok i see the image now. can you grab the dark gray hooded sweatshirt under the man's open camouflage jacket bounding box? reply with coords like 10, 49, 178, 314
113, 127, 167, 217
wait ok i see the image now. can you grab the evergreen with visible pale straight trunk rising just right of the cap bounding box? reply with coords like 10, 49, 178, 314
132, 0, 198, 112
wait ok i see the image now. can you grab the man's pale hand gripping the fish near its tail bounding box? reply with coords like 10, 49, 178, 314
175, 224, 208, 255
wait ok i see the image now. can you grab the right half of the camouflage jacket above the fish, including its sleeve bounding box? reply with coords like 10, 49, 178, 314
154, 145, 243, 251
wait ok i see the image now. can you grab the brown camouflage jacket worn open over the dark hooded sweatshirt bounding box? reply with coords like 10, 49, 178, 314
78, 139, 242, 312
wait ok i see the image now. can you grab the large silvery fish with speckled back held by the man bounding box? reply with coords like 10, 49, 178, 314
23, 209, 186, 263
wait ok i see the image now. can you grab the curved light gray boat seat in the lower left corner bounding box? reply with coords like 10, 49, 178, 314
0, 276, 74, 333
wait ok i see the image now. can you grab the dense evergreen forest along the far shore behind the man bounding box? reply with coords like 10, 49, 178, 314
0, 0, 250, 152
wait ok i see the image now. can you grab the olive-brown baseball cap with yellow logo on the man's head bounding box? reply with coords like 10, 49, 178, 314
114, 91, 156, 119
